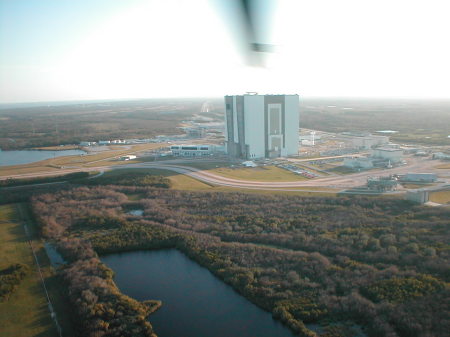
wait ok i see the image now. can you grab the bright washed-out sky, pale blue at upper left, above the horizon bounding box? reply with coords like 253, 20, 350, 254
0, 0, 450, 103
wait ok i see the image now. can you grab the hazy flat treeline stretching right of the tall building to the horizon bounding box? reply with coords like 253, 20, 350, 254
300, 98, 450, 145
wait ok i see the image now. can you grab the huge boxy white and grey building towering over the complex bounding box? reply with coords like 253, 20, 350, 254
225, 94, 299, 159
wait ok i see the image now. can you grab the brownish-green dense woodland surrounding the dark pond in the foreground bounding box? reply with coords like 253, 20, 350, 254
32, 185, 450, 337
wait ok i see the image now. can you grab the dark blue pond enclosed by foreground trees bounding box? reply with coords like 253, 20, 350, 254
102, 249, 294, 337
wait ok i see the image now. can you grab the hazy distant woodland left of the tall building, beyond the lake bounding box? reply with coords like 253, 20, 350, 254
0, 99, 204, 150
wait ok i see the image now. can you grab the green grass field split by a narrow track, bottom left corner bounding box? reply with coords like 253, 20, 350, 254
0, 204, 72, 337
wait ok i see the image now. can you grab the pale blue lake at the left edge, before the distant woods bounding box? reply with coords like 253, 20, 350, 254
0, 150, 86, 166
